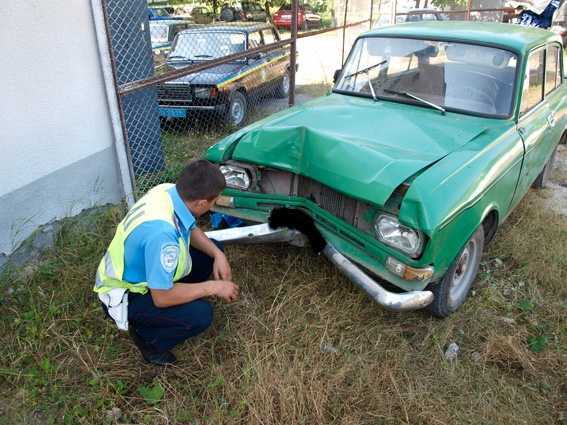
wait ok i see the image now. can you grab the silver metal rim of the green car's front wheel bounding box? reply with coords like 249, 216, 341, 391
448, 239, 480, 309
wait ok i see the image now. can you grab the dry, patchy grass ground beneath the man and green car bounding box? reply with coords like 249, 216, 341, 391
0, 163, 567, 425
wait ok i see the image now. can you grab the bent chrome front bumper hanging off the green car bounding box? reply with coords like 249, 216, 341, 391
207, 224, 433, 311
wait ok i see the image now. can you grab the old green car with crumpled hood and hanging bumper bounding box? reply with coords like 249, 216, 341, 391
203, 22, 567, 317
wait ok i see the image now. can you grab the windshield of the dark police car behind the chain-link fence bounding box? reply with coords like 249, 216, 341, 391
170, 31, 246, 60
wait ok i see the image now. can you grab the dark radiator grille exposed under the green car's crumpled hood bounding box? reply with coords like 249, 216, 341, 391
297, 176, 357, 226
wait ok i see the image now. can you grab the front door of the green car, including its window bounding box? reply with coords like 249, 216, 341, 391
515, 47, 550, 202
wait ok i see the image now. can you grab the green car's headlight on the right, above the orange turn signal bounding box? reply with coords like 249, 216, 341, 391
374, 215, 423, 258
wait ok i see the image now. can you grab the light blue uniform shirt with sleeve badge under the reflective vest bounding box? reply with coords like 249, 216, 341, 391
123, 186, 195, 289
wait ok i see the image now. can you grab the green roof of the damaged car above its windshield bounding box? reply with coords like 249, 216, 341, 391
362, 21, 561, 55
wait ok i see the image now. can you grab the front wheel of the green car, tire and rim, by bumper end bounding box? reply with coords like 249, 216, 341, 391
427, 225, 484, 317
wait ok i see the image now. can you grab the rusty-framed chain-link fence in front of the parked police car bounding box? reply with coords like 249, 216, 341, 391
103, 0, 378, 196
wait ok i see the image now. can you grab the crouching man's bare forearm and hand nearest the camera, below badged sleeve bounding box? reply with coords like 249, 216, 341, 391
150, 280, 239, 308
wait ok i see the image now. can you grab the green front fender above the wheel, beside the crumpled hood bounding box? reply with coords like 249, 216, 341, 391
400, 126, 524, 270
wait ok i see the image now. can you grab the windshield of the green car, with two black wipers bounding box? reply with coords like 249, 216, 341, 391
334, 37, 517, 118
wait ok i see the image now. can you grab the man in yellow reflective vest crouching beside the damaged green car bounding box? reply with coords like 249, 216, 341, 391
94, 160, 238, 365
